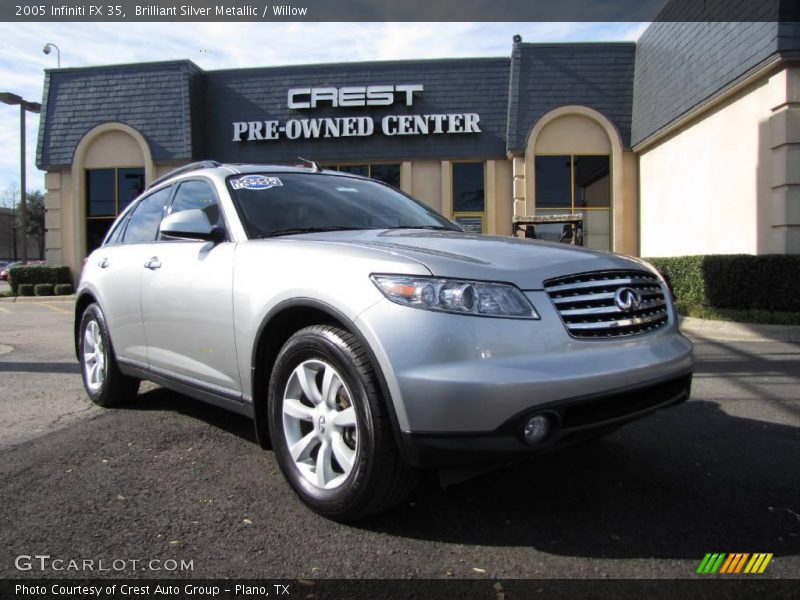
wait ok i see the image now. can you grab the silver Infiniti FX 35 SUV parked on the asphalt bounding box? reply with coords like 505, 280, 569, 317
75, 161, 692, 520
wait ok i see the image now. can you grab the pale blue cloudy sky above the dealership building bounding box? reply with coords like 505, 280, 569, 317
0, 23, 648, 202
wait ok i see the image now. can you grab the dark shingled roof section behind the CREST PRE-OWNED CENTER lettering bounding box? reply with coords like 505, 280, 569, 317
204, 58, 509, 163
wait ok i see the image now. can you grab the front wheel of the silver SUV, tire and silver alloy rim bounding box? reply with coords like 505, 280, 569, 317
269, 325, 417, 521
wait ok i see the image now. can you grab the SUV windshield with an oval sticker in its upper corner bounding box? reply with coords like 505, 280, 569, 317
228, 173, 461, 238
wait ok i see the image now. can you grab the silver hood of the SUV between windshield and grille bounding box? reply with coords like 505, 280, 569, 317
283, 229, 645, 290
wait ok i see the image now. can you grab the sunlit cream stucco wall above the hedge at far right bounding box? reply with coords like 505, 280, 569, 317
639, 70, 800, 256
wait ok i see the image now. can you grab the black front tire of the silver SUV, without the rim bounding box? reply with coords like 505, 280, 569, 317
268, 325, 418, 522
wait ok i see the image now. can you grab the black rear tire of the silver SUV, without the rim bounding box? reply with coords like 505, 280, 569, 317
78, 304, 139, 408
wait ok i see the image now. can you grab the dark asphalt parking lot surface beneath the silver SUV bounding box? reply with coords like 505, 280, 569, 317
0, 302, 800, 579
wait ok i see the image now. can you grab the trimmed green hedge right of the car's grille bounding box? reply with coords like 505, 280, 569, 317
645, 254, 800, 312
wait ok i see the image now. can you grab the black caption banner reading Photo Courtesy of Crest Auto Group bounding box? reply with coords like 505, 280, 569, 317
0, 575, 798, 600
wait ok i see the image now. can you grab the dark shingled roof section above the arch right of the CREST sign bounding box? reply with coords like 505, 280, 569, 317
508, 42, 636, 153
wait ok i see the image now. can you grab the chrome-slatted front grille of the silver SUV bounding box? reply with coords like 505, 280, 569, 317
544, 271, 669, 338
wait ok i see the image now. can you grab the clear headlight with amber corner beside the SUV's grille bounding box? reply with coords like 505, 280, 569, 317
371, 275, 539, 319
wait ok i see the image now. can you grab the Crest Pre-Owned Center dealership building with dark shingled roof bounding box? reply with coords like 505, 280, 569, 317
37, 22, 800, 274
